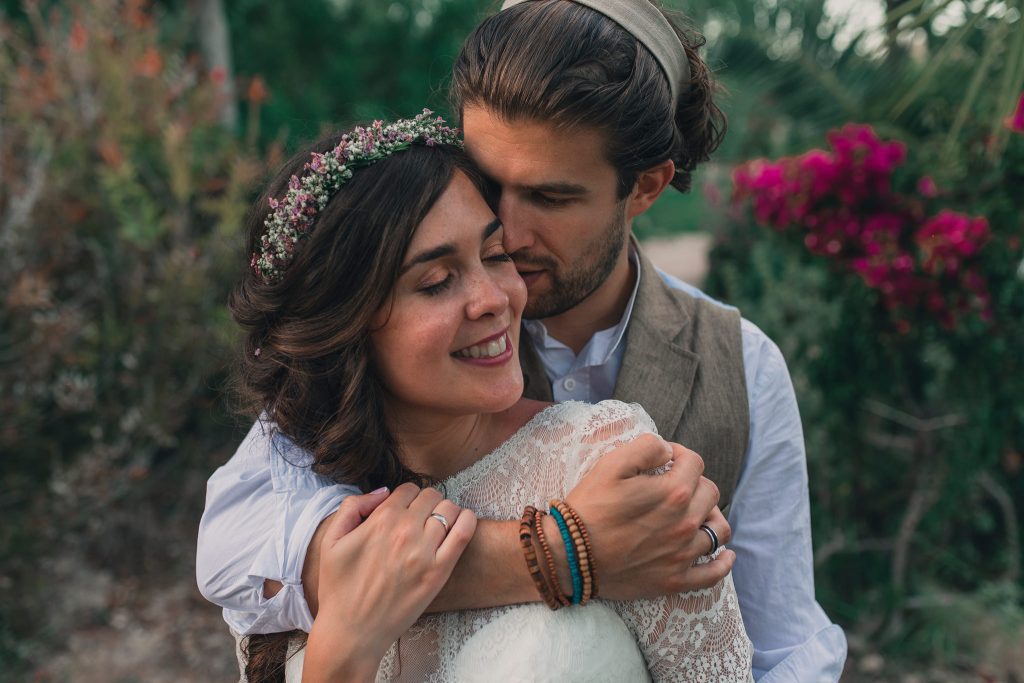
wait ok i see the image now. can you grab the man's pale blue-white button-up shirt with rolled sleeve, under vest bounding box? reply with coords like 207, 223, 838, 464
196, 259, 846, 683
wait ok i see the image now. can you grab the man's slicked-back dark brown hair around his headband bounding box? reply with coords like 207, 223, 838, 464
450, 0, 727, 199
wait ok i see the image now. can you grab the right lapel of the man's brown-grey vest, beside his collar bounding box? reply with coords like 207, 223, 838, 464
612, 247, 699, 439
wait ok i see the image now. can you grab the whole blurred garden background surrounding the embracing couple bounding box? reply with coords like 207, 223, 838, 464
0, 0, 1024, 683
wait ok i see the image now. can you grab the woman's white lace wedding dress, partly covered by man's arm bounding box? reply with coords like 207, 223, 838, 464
288, 400, 753, 683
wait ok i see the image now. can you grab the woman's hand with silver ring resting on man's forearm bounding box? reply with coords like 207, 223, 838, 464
302, 483, 476, 682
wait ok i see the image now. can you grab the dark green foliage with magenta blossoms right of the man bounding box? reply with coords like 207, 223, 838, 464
708, 0, 1024, 680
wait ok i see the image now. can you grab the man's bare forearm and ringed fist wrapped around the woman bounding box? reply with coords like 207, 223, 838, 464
302, 435, 735, 616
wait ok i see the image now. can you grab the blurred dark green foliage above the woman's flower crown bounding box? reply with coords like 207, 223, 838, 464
219, 0, 487, 139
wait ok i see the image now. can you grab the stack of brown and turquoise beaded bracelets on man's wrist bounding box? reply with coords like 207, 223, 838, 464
519, 500, 597, 609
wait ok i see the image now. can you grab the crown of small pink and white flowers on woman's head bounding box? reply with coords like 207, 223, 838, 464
250, 110, 462, 284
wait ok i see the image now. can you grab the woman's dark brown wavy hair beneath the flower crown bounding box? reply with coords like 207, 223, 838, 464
234, 135, 482, 683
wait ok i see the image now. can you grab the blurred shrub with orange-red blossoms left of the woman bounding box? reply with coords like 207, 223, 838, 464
0, 0, 273, 674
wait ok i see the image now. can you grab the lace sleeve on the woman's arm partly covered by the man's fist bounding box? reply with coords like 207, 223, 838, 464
566, 401, 753, 683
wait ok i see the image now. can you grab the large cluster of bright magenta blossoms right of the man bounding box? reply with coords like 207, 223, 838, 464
732, 127, 995, 334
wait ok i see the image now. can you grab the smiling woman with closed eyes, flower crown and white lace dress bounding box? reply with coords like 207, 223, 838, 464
230, 112, 752, 683
